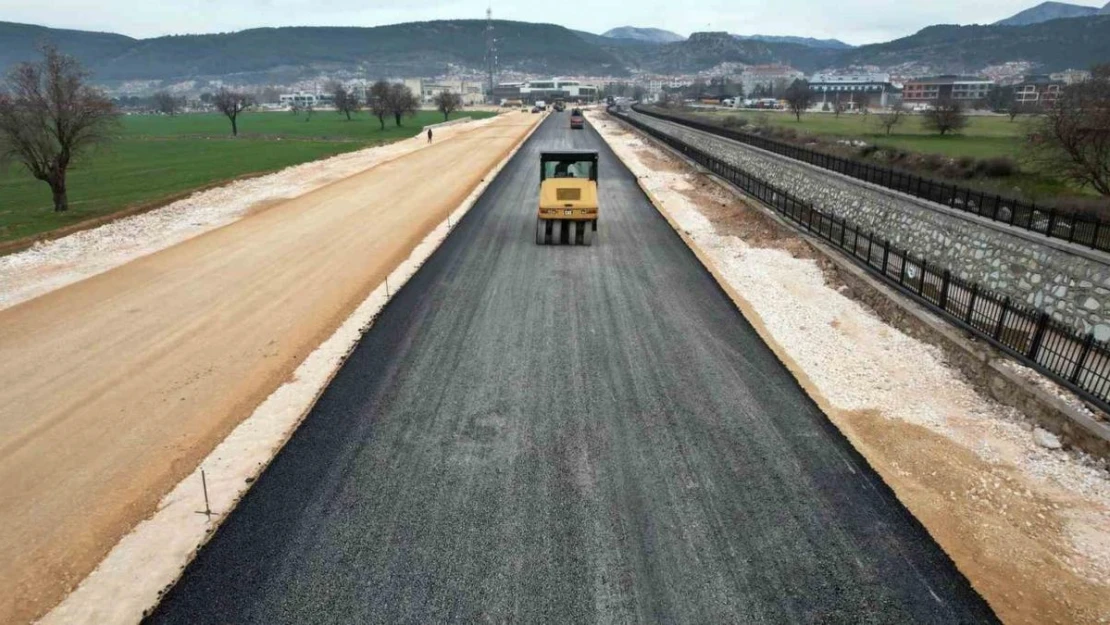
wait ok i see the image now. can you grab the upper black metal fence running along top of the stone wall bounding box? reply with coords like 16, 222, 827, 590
634, 108, 1110, 251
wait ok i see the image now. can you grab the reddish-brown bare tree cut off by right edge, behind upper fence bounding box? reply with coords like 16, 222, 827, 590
1033, 74, 1110, 195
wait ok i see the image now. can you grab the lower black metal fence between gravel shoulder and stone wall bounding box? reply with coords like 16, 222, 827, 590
614, 111, 1110, 412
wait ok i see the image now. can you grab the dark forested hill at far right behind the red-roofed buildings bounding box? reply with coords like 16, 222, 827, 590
836, 16, 1110, 73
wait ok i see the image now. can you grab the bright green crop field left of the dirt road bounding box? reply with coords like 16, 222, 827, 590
0, 111, 492, 242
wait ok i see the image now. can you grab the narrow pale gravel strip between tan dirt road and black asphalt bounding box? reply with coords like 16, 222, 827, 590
36, 115, 546, 625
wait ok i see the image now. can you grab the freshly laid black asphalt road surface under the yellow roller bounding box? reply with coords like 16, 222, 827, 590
149, 114, 995, 624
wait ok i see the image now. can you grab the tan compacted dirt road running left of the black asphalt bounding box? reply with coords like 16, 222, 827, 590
0, 115, 536, 623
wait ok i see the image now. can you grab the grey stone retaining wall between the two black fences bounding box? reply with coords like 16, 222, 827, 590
630, 113, 1110, 341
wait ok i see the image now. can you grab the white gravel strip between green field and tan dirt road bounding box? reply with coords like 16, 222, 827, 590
0, 118, 494, 310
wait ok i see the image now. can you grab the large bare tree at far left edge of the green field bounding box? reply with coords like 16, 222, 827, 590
0, 46, 119, 212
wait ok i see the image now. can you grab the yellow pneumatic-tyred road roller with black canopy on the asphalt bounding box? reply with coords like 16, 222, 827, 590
536, 150, 597, 245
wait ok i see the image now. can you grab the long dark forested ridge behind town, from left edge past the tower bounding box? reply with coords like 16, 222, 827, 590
0, 20, 627, 83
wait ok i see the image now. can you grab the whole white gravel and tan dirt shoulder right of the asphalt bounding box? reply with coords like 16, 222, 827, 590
593, 109, 1110, 624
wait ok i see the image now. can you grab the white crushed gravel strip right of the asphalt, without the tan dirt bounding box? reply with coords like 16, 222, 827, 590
592, 113, 1110, 586
